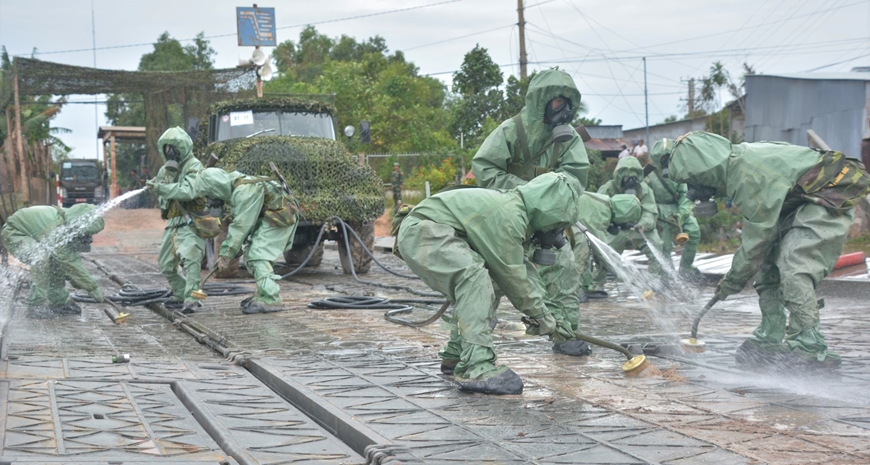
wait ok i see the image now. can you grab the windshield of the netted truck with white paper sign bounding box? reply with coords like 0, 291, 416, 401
217, 111, 335, 141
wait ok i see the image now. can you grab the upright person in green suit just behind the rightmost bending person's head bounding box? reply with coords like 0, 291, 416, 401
644, 139, 701, 280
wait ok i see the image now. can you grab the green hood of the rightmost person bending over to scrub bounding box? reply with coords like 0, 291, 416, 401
669, 132, 732, 190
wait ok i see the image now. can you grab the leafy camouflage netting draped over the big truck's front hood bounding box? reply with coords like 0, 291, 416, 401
208, 136, 384, 222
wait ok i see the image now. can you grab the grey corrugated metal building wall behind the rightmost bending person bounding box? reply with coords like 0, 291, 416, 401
744, 72, 870, 160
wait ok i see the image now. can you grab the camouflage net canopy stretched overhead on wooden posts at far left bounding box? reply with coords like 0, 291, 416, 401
0, 57, 256, 169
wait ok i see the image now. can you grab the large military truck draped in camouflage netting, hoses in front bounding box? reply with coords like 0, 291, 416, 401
195, 96, 384, 273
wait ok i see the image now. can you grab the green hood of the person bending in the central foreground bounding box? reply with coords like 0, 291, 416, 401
516, 173, 583, 231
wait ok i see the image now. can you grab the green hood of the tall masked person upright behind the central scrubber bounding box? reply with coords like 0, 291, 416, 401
523, 69, 580, 130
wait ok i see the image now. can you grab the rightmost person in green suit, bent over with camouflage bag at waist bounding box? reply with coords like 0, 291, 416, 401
670, 132, 870, 368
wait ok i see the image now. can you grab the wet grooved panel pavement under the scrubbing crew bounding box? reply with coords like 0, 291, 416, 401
0, 208, 870, 464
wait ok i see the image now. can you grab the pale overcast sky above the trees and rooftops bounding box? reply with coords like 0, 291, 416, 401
0, 0, 870, 158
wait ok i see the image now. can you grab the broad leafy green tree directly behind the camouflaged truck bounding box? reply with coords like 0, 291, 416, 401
265, 26, 456, 153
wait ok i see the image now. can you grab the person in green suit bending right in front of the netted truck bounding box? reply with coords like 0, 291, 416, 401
196, 168, 297, 314
